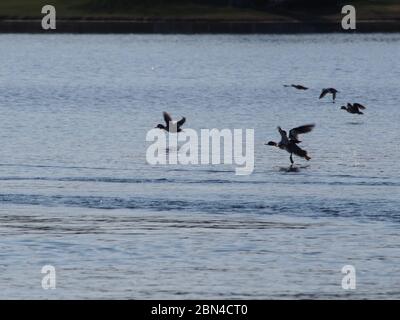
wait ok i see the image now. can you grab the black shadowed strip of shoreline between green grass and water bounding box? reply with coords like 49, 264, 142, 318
0, 18, 400, 34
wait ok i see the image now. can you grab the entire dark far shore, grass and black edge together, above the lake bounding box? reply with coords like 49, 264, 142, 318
0, 0, 400, 33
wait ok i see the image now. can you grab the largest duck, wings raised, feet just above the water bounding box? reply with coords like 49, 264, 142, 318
266, 124, 315, 166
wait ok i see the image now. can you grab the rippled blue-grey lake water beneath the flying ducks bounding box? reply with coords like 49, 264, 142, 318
0, 34, 400, 299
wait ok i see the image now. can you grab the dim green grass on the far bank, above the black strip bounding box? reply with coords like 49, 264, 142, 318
0, 0, 400, 21
